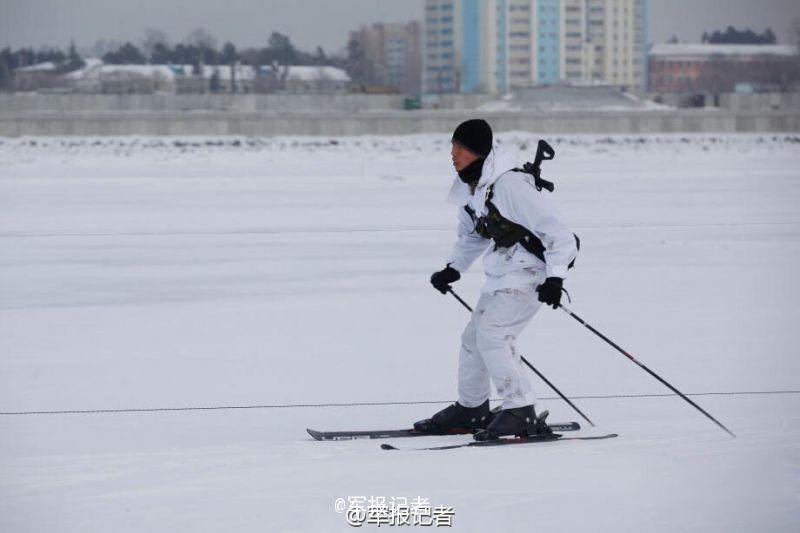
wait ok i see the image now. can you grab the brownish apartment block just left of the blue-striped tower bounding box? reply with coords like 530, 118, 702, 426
350, 21, 422, 94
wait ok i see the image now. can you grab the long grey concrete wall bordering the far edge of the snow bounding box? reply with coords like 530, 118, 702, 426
0, 110, 800, 136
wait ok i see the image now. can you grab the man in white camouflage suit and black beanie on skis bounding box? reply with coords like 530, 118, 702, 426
414, 119, 578, 440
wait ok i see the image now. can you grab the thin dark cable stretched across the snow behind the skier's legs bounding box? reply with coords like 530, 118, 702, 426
0, 390, 800, 416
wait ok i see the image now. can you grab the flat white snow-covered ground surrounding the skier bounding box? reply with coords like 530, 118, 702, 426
0, 133, 800, 532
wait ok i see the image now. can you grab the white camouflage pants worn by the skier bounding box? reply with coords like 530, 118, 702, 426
458, 287, 541, 409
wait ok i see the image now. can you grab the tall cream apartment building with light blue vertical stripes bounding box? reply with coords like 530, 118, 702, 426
423, 0, 648, 93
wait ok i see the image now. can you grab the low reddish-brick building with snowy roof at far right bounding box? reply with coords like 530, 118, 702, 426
649, 44, 800, 94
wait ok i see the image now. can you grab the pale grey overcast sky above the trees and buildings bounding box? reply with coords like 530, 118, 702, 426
0, 0, 800, 53
